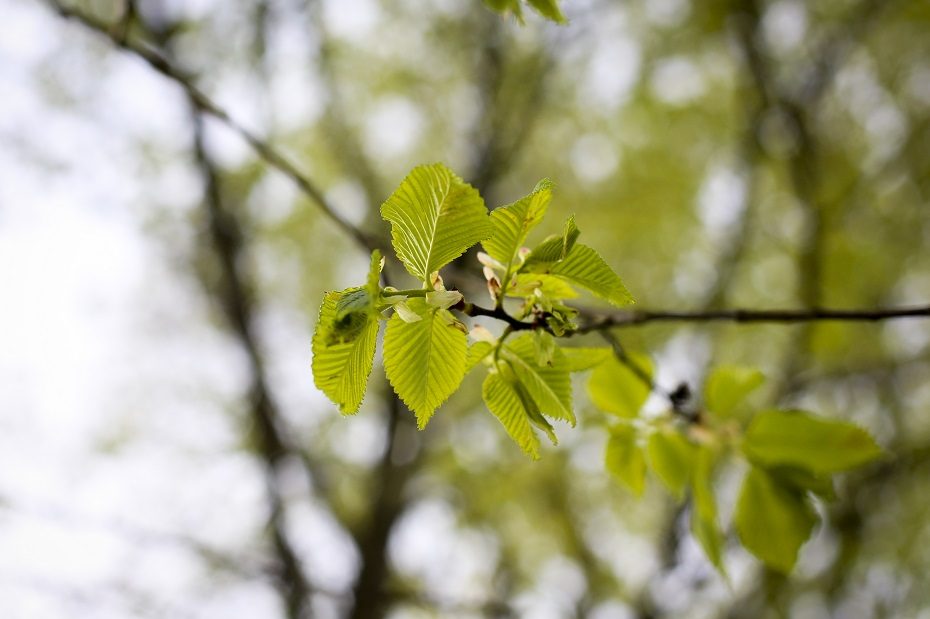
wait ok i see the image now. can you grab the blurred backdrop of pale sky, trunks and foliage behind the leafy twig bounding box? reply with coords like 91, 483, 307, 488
0, 0, 930, 619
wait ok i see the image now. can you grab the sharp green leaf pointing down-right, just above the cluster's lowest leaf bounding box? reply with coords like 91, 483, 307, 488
501, 332, 575, 426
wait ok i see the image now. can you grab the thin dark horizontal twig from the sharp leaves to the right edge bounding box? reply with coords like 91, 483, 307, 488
576, 305, 930, 333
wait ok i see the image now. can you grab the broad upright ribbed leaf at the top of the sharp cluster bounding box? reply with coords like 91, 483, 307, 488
381, 163, 491, 283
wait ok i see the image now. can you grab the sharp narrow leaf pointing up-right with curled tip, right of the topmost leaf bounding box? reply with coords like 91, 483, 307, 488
481, 178, 552, 273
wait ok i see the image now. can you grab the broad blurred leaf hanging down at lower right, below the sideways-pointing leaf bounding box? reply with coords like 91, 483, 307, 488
735, 467, 817, 574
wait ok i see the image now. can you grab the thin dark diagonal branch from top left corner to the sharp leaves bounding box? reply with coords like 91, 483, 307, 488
46, 0, 380, 250
